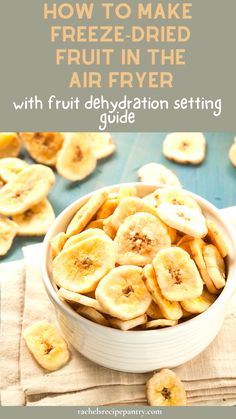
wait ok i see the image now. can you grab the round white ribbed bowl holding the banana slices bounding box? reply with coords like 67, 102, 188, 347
42, 183, 236, 373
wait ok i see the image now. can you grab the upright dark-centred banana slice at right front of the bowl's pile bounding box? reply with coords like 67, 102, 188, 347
152, 247, 203, 301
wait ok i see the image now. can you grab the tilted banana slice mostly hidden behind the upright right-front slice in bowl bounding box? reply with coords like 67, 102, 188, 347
144, 265, 183, 320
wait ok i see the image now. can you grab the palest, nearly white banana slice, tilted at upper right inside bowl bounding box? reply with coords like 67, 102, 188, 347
157, 203, 207, 238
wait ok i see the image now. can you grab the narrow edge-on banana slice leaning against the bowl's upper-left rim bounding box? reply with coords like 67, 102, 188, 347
66, 191, 107, 236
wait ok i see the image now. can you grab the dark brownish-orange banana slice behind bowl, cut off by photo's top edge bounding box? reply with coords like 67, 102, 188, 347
20, 132, 64, 166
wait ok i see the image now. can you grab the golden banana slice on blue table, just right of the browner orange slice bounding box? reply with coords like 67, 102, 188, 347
56, 132, 97, 182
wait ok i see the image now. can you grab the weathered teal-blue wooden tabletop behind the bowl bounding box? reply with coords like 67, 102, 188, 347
0, 133, 236, 262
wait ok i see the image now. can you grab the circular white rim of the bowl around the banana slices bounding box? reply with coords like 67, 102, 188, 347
40, 182, 236, 337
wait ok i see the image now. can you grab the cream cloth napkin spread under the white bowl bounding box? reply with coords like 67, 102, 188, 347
0, 207, 236, 406
